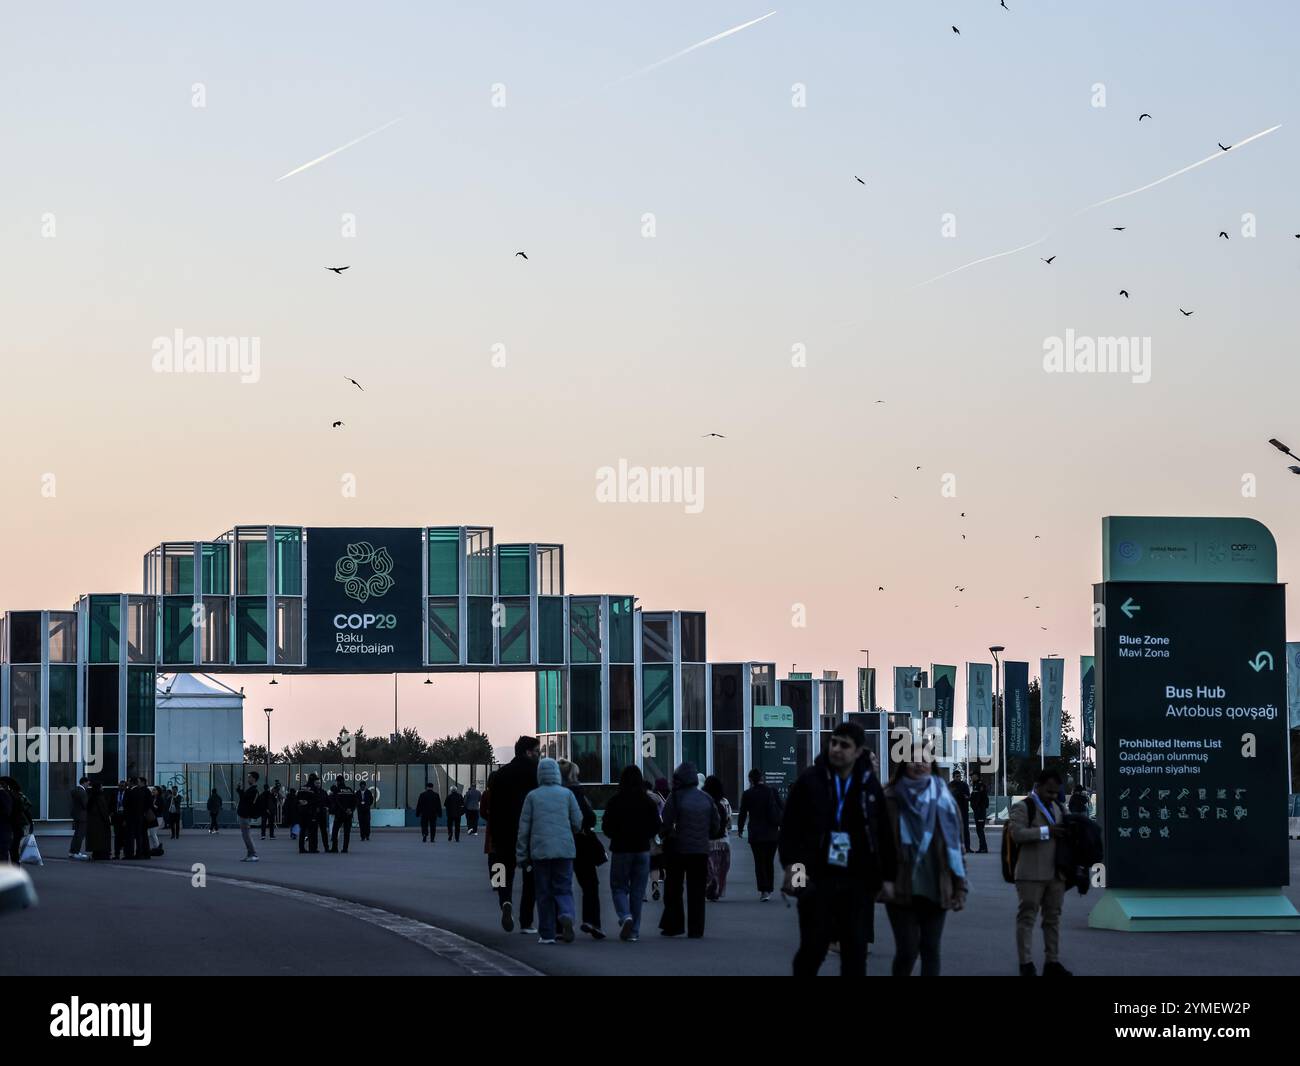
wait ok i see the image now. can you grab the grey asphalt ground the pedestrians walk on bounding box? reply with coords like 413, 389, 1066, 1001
0, 829, 1300, 976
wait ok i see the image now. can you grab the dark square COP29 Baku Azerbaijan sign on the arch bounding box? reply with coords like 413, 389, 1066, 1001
307, 528, 424, 673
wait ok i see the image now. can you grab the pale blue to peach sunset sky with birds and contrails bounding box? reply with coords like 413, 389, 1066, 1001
0, 0, 1300, 748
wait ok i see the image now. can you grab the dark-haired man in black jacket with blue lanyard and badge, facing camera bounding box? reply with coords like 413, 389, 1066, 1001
780, 722, 898, 978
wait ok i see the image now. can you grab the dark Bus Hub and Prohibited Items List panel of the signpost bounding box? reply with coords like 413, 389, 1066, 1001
1096, 581, 1288, 889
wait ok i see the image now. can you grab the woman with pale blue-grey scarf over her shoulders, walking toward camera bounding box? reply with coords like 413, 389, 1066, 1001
885, 762, 967, 978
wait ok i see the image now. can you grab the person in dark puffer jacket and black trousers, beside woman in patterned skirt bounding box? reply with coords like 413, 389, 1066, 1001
659, 763, 723, 940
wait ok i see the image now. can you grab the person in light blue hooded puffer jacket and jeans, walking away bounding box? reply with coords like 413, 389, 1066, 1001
515, 759, 582, 944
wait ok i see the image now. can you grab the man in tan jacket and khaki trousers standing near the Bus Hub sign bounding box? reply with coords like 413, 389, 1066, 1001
1008, 767, 1071, 978
